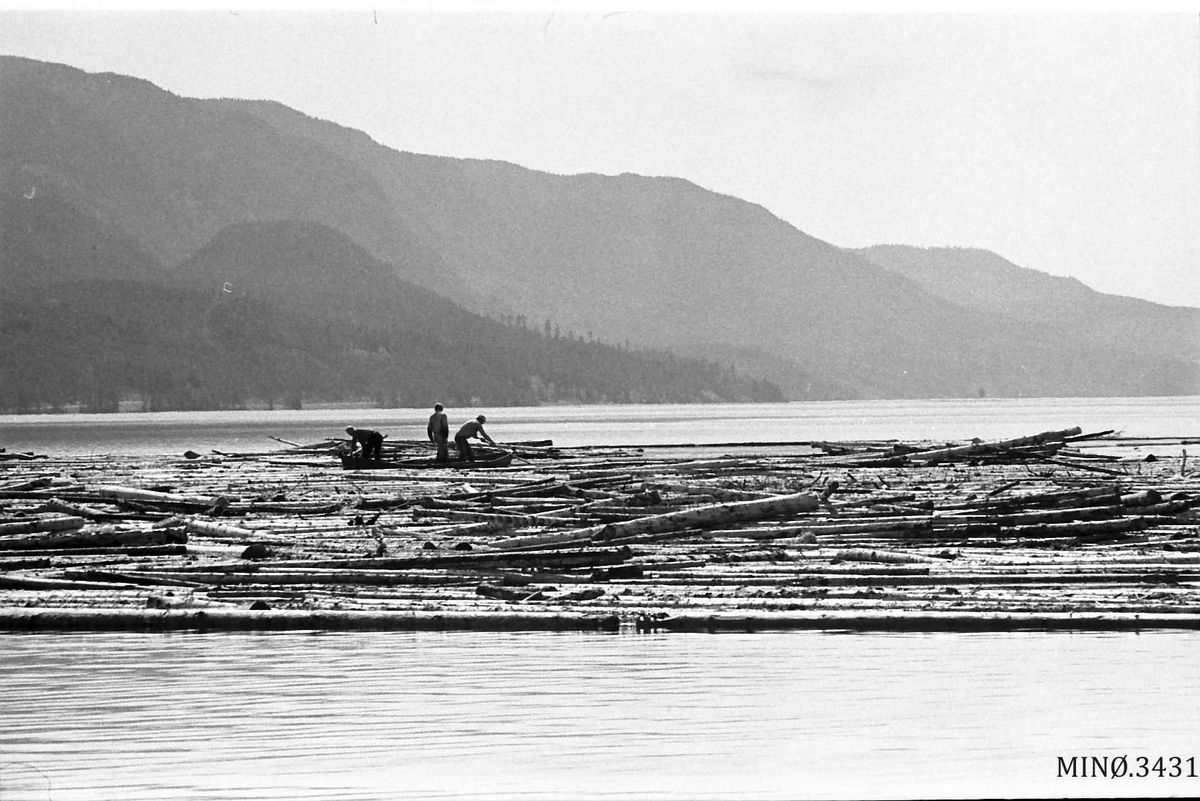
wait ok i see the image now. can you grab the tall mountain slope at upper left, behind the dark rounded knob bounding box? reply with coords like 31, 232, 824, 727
0, 56, 440, 287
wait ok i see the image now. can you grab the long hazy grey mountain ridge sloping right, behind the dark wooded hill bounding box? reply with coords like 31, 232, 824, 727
231, 101, 1200, 398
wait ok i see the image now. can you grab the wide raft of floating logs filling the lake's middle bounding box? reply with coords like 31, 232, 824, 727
0, 427, 1200, 632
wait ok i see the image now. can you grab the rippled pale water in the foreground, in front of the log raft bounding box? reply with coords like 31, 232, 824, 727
0, 632, 1200, 801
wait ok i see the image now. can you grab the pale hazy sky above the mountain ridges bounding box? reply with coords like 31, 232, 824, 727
0, 8, 1200, 306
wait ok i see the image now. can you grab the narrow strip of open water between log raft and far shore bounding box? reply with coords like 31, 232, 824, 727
0, 397, 1200, 456
